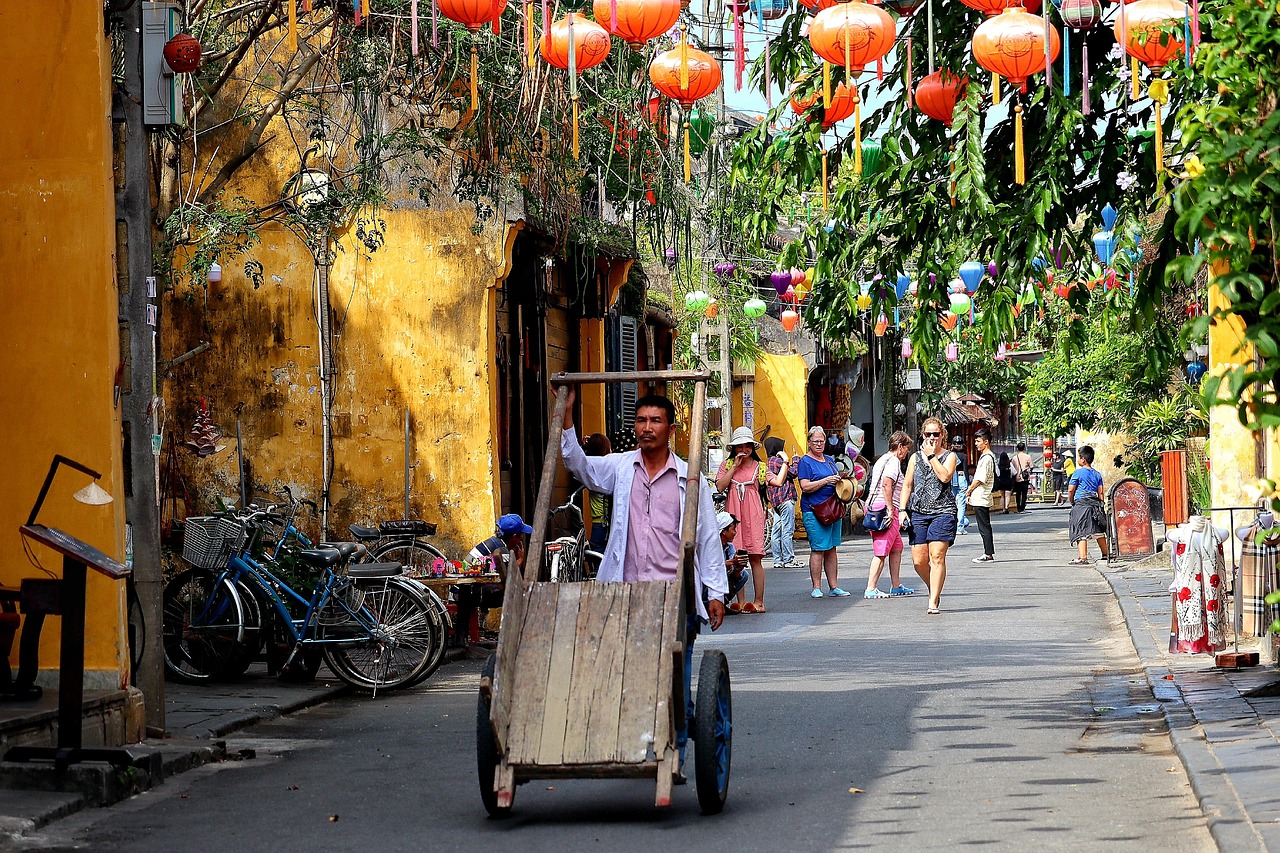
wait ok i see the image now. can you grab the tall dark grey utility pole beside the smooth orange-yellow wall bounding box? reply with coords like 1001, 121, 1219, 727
111, 3, 165, 729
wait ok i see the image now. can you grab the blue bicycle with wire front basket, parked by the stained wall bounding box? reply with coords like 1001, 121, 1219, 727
163, 511, 443, 693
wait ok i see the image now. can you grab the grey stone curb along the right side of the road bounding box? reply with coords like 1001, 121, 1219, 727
1094, 566, 1267, 853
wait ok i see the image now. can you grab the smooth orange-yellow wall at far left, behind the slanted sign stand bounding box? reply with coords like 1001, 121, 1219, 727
0, 6, 128, 686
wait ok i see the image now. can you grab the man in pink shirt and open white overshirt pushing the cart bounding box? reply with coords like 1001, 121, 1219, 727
561, 386, 728, 783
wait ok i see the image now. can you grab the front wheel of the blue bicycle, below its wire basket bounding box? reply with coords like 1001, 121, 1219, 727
161, 569, 244, 684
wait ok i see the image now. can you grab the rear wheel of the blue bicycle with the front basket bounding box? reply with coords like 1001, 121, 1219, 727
319, 583, 443, 692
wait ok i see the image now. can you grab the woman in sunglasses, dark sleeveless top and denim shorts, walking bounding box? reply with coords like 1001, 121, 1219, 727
899, 418, 957, 615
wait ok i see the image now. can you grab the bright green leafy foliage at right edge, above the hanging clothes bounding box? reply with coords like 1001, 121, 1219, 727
1169, 0, 1280, 429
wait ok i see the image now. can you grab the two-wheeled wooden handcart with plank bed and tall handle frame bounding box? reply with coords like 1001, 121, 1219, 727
476, 370, 732, 816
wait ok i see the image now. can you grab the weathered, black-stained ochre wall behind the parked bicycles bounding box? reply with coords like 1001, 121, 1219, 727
169, 206, 511, 557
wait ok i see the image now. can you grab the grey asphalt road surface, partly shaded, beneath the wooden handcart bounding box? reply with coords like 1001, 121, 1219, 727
26, 510, 1213, 853
